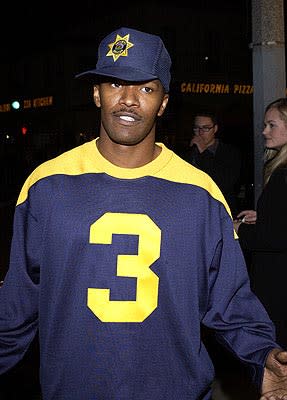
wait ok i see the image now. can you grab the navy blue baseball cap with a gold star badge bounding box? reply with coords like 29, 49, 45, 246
76, 27, 171, 93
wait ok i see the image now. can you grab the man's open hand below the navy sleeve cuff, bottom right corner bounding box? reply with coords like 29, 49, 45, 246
259, 349, 287, 400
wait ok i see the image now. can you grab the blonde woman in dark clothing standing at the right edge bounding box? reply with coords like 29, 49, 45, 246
234, 98, 287, 347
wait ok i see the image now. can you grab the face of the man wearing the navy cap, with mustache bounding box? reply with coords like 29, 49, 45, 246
94, 80, 168, 146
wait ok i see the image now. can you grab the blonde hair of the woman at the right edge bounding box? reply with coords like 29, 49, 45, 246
264, 97, 287, 186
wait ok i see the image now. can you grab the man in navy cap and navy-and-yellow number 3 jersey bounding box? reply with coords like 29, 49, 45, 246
0, 28, 287, 400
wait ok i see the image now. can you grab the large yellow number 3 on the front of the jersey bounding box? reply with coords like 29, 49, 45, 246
88, 213, 161, 322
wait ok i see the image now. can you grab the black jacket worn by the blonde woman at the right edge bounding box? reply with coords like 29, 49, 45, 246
238, 168, 287, 348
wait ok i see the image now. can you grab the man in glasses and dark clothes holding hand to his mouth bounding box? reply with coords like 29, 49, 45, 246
182, 110, 242, 216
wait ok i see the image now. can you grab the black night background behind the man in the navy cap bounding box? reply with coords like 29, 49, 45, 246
0, 0, 284, 400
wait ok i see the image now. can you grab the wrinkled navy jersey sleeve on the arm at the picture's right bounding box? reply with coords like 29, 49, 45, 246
203, 208, 280, 386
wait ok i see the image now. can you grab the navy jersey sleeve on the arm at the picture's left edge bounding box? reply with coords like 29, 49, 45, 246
0, 192, 41, 374
